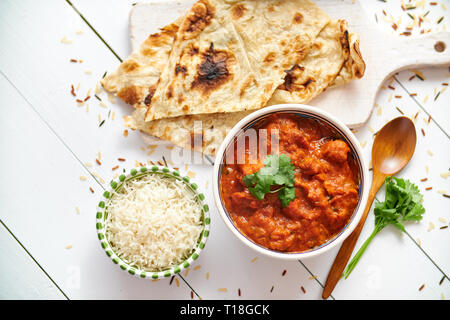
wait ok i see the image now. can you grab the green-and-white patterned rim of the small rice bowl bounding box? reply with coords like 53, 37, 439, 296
95, 165, 211, 280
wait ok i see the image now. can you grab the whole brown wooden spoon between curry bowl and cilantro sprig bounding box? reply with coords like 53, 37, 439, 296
322, 117, 416, 299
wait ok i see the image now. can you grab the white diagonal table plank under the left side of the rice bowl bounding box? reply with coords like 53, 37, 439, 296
0, 65, 190, 299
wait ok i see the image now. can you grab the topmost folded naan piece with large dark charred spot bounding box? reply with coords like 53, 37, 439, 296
145, 0, 329, 121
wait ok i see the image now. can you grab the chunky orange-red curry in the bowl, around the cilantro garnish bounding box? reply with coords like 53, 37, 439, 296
221, 114, 359, 252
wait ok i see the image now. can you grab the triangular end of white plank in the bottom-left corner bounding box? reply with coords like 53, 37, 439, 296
0, 225, 66, 300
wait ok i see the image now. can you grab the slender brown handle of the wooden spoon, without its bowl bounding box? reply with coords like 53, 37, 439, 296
322, 172, 385, 299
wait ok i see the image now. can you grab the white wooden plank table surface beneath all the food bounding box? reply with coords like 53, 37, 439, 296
0, 0, 450, 299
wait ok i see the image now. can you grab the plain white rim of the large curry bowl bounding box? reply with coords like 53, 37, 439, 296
212, 104, 370, 260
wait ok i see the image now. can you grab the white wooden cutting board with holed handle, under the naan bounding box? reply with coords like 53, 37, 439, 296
130, 0, 450, 128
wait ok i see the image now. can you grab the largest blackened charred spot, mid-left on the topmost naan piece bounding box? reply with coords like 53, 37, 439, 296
191, 43, 234, 94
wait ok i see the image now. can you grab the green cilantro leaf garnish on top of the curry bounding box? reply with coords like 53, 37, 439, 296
242, 154, 295, 207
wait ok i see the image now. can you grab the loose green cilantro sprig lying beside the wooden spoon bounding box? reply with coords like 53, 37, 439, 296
343, 177, 425, 279
